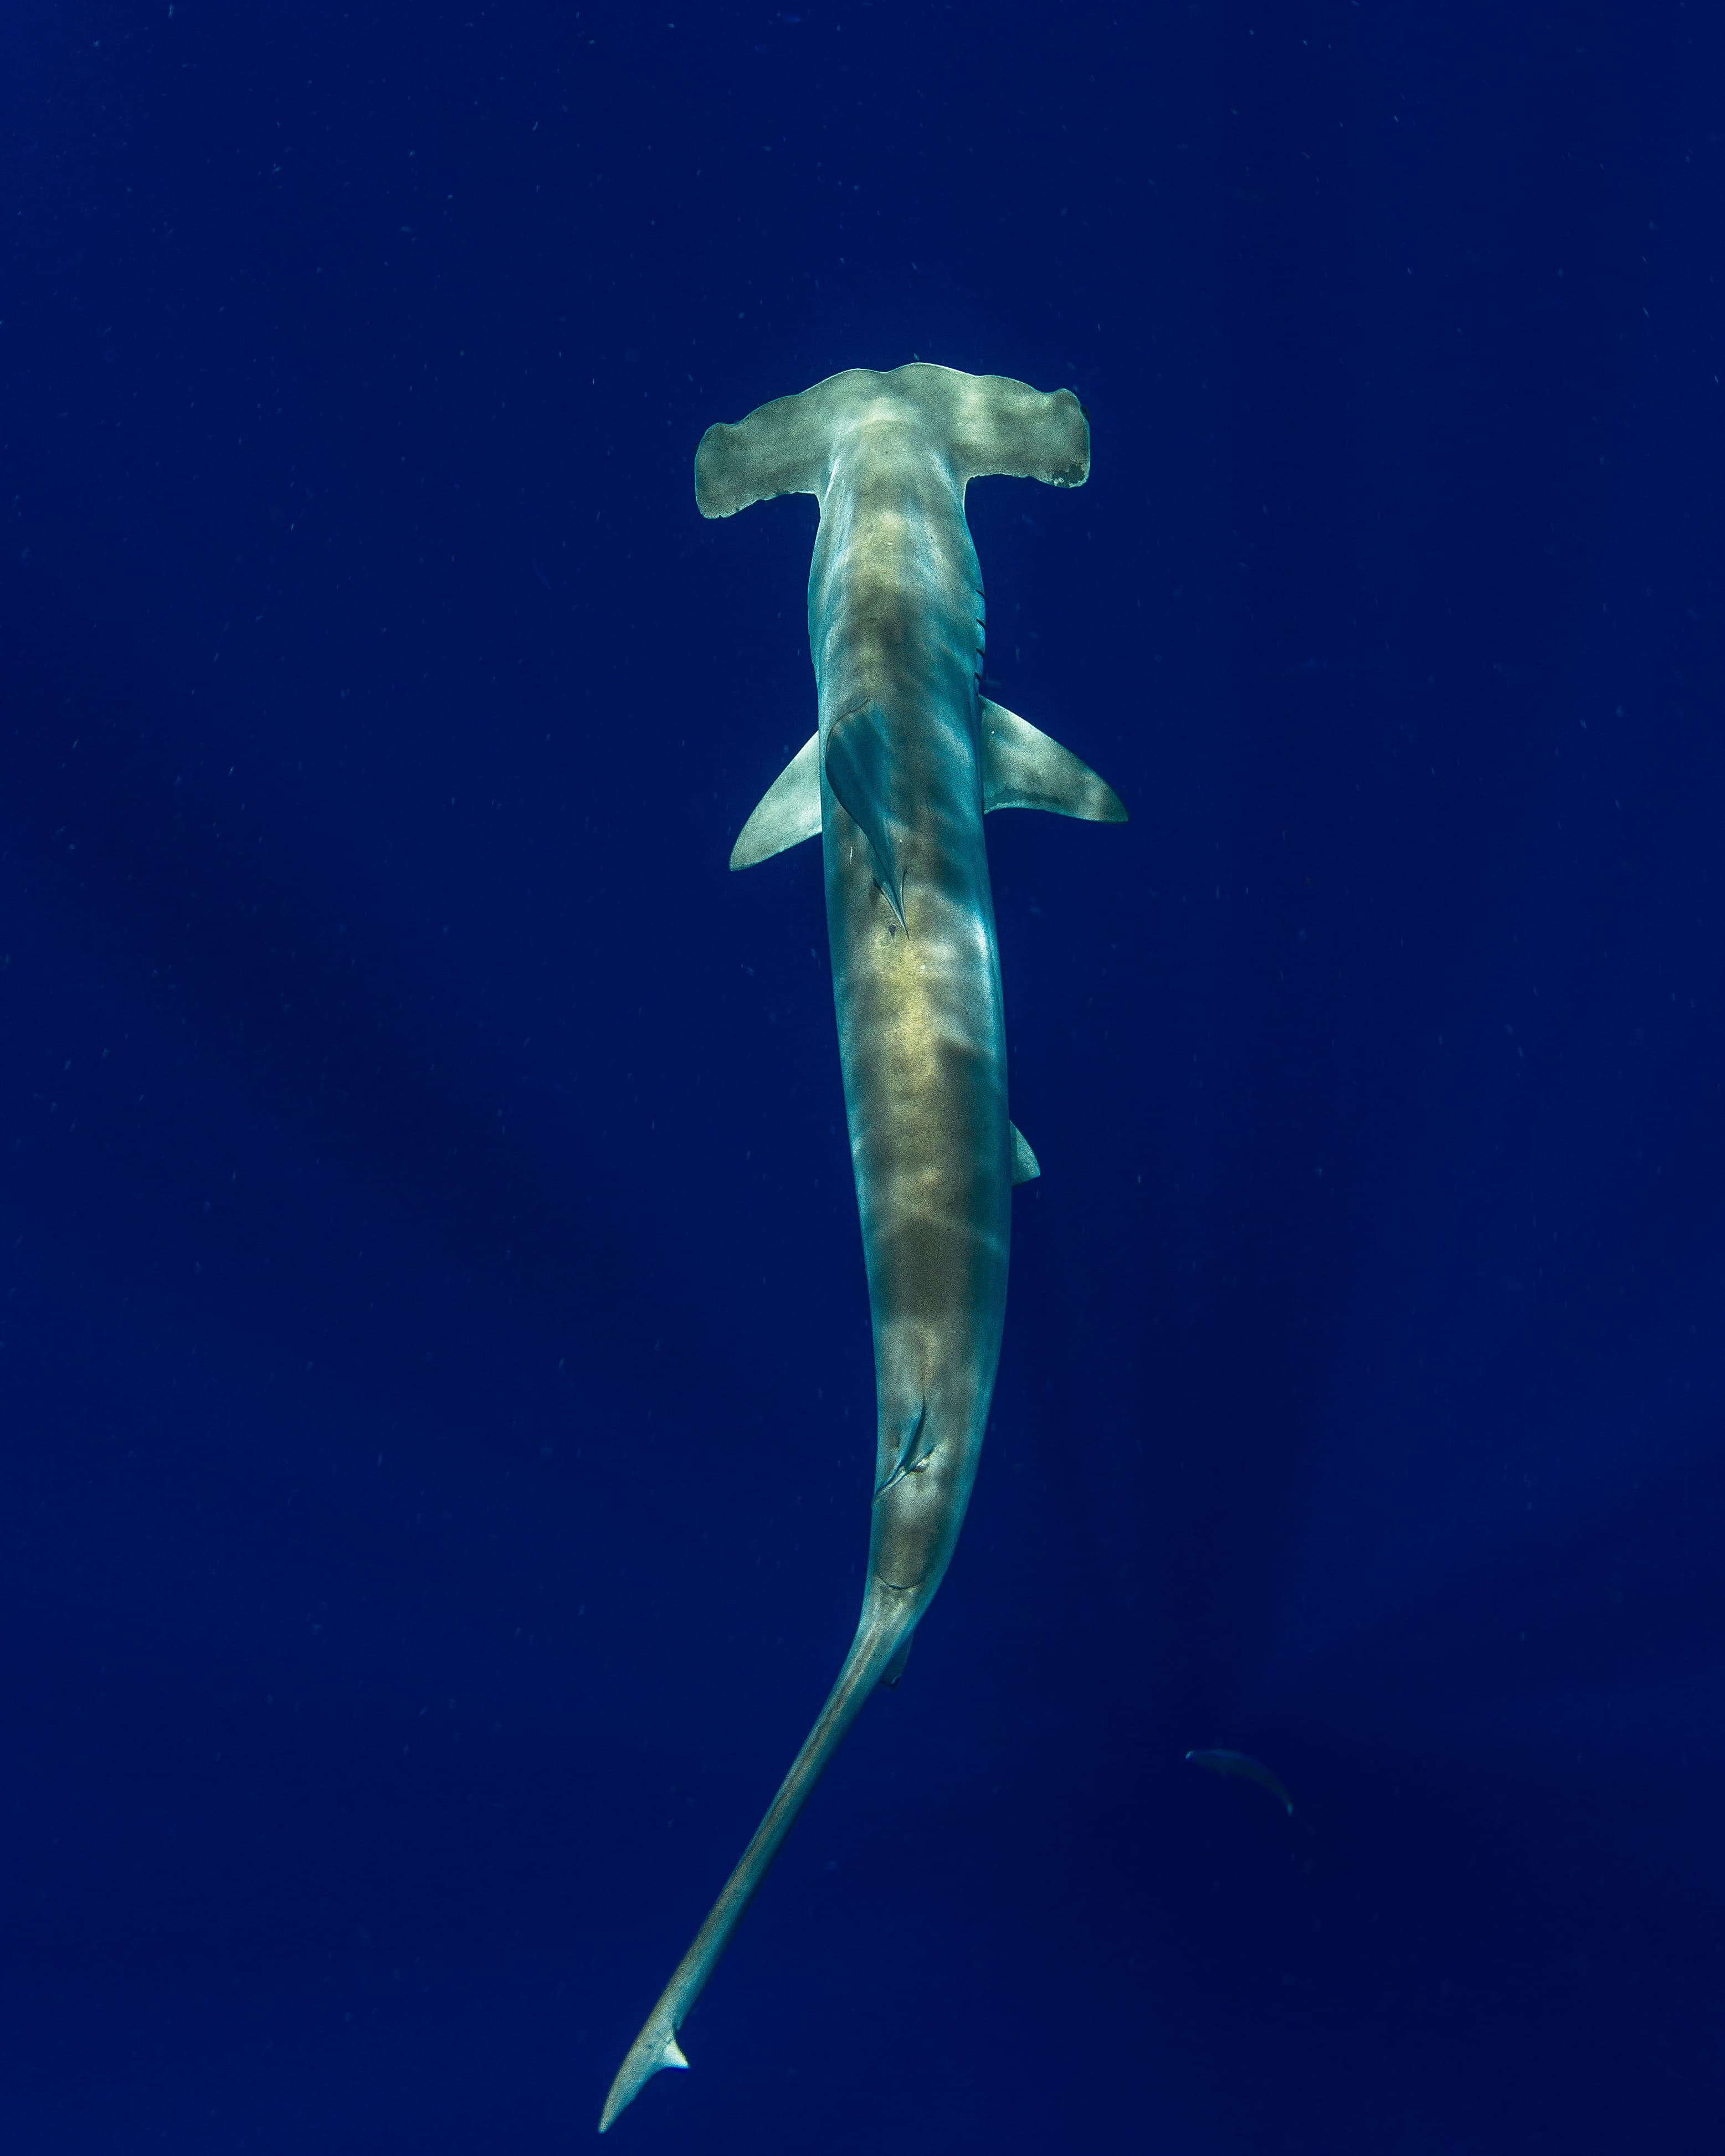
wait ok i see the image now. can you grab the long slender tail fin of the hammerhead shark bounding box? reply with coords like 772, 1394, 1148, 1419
599, 1580, 927, 2132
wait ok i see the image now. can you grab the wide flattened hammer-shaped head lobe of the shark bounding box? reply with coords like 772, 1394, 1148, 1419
694, 360, 1091, 517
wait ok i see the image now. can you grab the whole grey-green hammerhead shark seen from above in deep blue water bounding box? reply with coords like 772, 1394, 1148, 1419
599, 362, 1126, 2132
